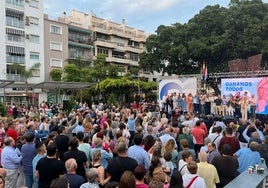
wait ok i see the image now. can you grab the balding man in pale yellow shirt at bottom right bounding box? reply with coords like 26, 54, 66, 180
197, 151, 220, 188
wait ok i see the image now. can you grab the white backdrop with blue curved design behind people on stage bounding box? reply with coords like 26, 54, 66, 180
158, 78, 197, 101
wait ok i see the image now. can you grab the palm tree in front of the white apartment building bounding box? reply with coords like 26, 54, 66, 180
11, 63, 41, 105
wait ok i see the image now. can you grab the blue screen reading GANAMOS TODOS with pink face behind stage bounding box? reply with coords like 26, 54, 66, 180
221, 77, 268, 114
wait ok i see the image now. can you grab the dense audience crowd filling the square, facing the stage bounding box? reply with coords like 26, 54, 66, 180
0, 96, 268, 188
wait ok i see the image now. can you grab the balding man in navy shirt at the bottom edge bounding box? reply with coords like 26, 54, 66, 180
65, 158, 85, 188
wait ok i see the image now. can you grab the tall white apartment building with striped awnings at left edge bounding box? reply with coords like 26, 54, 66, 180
0, 0, 44, 104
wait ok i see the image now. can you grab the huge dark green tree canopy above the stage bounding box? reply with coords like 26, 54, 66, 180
140, 0, 268, 75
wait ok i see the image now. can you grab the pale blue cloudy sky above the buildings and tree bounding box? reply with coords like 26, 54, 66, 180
44, 0, 268, 34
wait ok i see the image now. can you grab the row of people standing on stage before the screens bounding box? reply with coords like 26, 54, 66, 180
161, 91, 258, 119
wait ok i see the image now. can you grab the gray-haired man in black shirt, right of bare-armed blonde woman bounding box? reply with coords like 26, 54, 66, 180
107, 142, 138, 182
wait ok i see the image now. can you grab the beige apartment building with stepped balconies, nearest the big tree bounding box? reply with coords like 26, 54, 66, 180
58, 10, 148, 73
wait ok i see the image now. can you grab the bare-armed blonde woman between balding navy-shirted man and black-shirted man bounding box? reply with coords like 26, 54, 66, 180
92, 150, 111, 187
